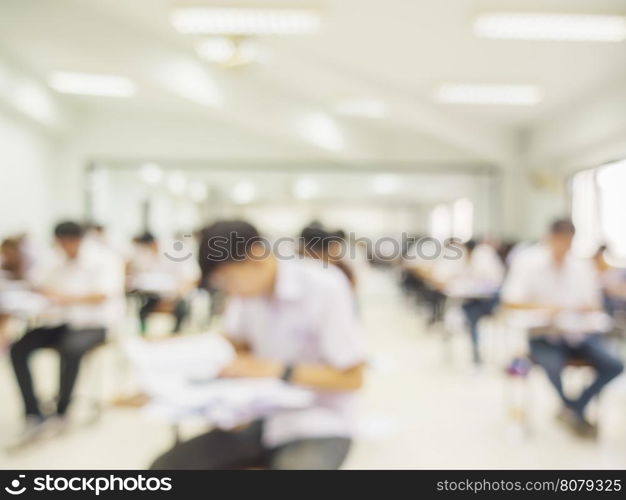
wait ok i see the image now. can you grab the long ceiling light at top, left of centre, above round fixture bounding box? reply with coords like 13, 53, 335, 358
172, 7, 320, 35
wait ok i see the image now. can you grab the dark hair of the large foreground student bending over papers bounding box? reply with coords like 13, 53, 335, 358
198, 220, 261, 284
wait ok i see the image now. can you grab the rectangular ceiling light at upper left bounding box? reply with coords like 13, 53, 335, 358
48, 72, 135, 97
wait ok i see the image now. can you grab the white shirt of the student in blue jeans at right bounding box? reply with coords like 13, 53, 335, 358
502, 244, 610, 333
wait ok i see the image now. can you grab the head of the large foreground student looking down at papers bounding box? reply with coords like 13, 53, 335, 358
198, 220, 276, 297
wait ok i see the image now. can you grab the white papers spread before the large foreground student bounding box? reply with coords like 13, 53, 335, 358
126, 334, 313, 429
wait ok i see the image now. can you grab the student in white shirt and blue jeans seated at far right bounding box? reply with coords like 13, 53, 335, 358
502, 219, 623, 437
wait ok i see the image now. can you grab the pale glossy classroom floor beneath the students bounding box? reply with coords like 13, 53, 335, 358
0, 270, 626, 470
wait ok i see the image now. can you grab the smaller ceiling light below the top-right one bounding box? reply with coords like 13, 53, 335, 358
435, 83, 542, 106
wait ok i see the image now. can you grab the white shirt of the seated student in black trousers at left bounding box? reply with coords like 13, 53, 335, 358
36, 240, 124, 328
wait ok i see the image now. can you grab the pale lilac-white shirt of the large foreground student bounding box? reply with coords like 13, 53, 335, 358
225, 259, 364, 447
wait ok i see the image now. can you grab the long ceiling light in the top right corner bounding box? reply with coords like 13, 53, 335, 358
474, 12, 626, 42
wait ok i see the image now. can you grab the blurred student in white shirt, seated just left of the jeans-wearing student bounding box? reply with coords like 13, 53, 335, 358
435, 240, 504, 365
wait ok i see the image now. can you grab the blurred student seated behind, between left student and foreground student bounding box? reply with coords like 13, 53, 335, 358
128, 233, 200, 333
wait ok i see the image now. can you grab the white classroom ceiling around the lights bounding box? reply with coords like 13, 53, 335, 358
0, 0, 626, 162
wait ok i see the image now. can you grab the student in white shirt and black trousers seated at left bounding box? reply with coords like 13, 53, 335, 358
11, 222, 123, 437
